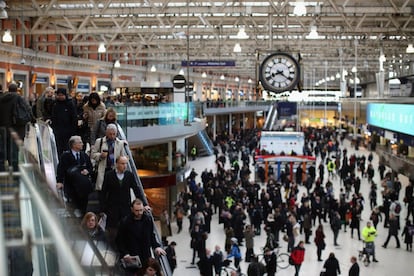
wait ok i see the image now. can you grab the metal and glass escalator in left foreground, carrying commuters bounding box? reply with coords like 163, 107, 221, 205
0, 122, 172, 276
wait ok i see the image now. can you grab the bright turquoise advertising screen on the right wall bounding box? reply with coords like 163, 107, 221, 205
367, 103, 414, 135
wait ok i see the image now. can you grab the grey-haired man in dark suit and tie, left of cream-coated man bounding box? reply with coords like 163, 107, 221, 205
56, 135, 93, 217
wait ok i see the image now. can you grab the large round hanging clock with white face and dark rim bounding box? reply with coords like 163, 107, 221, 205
259, 53, 300, 93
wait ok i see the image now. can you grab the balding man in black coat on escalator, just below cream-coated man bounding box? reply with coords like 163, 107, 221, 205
100, 156, 144, 243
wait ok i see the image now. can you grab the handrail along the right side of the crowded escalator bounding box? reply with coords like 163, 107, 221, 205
117, 124, 172, 276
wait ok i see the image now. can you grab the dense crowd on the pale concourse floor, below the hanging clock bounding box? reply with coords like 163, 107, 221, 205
174, 129, 414, 276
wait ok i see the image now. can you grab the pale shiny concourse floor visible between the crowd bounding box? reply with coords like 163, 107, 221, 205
168, 141, 414, 276
